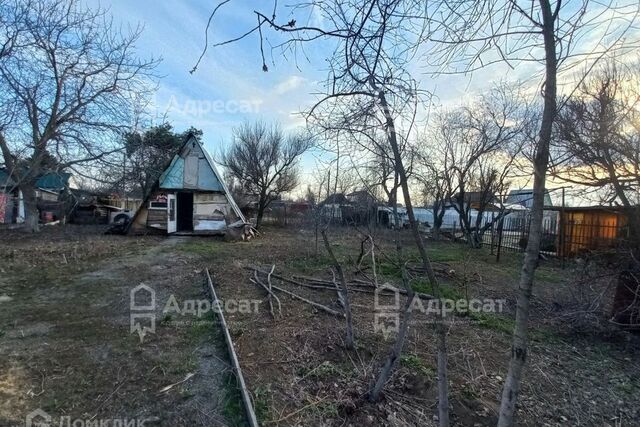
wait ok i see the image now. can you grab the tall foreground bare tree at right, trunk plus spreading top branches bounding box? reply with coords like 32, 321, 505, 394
428, 0, 640, 427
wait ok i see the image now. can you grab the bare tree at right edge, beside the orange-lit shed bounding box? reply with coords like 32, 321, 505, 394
551, 61, 640, 325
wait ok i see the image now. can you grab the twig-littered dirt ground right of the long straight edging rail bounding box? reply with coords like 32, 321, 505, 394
191, 228, 640, 426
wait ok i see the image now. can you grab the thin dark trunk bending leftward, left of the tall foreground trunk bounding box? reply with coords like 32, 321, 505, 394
374, 87, 449, 427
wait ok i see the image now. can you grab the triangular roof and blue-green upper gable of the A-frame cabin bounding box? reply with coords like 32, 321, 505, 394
129, 132, 247, 231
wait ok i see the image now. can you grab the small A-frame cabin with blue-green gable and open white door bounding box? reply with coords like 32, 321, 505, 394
129, 134, 246, 235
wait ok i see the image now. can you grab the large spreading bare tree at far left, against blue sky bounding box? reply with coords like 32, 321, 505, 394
0, 0, 157, 231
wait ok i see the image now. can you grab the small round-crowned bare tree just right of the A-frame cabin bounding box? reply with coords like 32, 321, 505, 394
220, 122, 313, 227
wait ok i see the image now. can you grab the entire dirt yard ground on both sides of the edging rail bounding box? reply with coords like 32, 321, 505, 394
0, 227, 640, 426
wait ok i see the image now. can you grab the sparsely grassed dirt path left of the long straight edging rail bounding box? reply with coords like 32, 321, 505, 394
0, 236, 239, 426
